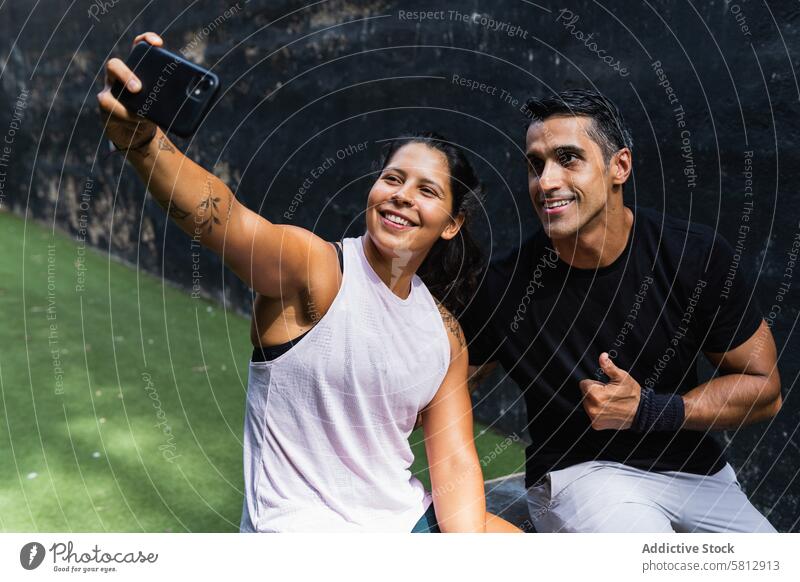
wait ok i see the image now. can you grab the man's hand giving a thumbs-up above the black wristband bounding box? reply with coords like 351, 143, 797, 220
578, 352, 642, 430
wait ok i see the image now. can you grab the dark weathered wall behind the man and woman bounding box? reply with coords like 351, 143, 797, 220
0, 0, 800, 530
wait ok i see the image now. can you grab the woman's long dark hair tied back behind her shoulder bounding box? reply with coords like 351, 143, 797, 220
380, 131, 483, 317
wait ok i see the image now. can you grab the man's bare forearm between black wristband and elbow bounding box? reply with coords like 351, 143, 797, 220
683, 374, 781, 430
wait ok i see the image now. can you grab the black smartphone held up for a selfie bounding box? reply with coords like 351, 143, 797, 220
111, 42, 220, 137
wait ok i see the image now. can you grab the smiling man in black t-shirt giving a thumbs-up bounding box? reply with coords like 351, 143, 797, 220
462, 90, 781, 532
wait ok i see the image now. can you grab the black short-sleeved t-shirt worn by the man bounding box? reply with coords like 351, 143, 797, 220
461, 208, 761, 486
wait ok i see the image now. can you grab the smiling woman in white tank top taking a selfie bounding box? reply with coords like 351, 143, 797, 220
98, 33, 518, 532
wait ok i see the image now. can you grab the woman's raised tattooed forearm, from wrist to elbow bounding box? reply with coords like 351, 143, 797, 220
127, 129, 236, 250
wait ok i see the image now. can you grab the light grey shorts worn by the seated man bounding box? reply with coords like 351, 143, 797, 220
528, 461, 775, 533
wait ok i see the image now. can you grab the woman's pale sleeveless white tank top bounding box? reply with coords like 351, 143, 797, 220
240, 236, 450, 532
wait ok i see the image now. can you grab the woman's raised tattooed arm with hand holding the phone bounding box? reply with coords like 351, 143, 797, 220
97, 32, 331, 298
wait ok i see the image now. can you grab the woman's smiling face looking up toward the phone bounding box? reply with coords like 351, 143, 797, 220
366, 141, 463, 259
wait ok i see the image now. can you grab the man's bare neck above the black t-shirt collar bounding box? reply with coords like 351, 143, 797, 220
552, 205, 633, 269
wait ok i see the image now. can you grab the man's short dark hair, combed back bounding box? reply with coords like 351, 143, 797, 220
525, 89, 633, 163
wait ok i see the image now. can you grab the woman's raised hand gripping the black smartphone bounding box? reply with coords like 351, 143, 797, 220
97, 32, 164, 151
